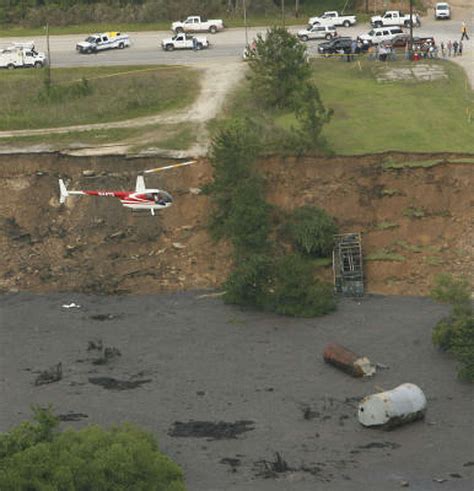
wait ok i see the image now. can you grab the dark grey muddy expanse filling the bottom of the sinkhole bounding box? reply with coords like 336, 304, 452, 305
0, 292, 474, 491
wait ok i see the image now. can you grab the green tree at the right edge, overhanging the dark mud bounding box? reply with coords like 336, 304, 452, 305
431, 274, 474, 382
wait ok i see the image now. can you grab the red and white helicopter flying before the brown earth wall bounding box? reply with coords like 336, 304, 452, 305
59, 160, 196, 215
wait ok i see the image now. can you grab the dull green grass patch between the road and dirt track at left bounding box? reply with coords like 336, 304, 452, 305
0, 66, 200, 130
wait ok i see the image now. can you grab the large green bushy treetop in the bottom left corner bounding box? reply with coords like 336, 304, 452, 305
0, 411, 185, 491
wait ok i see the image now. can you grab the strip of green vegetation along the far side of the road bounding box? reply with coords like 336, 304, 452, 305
0, 0, 352, 27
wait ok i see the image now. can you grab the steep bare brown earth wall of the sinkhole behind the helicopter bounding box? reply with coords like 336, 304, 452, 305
0, 154, 474, 295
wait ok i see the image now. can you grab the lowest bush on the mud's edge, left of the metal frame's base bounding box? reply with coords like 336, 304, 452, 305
271, 254, 336, 317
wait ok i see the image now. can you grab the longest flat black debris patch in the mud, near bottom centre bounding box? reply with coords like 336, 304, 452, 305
168, 420, 254, 440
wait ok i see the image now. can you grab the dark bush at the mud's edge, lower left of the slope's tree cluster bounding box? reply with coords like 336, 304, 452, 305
224, 254, 272, 308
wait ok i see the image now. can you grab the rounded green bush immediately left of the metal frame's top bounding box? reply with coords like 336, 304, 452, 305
283, 206, 337, 257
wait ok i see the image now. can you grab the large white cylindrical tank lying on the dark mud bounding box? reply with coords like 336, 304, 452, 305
358, 384, 426, 428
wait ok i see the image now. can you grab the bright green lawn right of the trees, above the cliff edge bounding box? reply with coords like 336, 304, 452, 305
256, 58, 474, 155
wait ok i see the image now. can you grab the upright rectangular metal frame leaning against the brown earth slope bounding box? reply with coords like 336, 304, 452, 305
332, 233, 364, 297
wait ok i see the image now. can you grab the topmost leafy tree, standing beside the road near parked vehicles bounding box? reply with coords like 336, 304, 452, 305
249, 27, 311, 108
